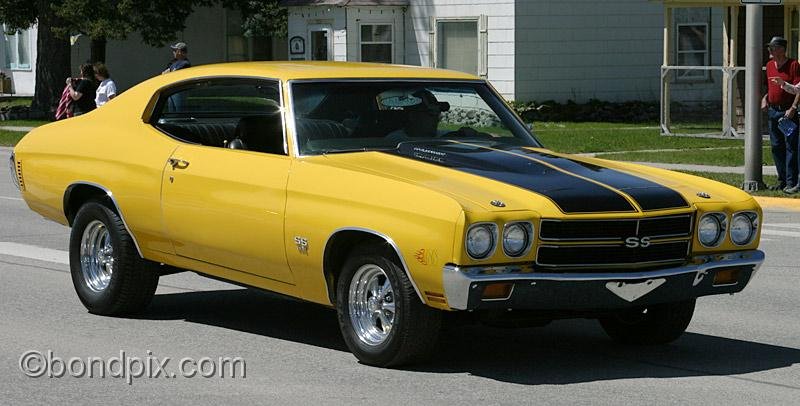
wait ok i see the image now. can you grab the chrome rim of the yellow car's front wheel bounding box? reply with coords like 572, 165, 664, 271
349, 264, 395, 345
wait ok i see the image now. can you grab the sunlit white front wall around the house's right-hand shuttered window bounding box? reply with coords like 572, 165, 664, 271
405, 0, 515, 100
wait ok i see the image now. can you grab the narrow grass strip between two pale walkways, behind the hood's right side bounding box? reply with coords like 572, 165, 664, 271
597, 147, 774, 166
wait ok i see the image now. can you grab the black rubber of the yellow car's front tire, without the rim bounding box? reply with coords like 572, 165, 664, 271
336, 245, 442, 367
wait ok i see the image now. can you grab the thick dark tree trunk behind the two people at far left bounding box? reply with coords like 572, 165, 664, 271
31, 0, 70, 118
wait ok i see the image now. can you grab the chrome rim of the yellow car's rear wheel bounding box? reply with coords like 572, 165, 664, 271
80, 220, 114, 292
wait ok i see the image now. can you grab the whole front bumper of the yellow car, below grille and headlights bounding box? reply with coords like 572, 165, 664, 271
443, 250, 764, 310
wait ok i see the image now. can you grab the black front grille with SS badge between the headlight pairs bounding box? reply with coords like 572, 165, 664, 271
536, 214, 693, 272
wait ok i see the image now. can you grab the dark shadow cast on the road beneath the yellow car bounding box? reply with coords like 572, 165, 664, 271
137, 289, 800, 389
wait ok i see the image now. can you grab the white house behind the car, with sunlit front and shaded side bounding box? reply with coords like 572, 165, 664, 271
281, 0, 664, 102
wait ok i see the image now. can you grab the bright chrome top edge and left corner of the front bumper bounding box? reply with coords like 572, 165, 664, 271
442, 250, 764, 310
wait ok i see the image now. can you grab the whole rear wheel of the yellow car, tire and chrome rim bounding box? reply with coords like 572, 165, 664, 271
69, 201, 158, 315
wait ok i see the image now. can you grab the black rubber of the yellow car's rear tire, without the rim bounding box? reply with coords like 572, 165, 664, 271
69, 201, 159, 315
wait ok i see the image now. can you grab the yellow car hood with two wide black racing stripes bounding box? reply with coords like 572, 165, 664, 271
316, 141, 750, 215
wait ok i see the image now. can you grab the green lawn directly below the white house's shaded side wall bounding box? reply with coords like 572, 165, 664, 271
534, 122, 744, 154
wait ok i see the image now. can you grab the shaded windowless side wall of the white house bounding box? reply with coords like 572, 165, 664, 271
515, 0, 664, 102
